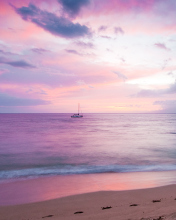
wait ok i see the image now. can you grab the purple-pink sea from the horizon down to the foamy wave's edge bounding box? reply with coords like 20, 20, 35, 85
0, 114, 176, 181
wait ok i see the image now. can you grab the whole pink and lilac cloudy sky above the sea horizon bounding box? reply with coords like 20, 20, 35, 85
0, 0, 176, 113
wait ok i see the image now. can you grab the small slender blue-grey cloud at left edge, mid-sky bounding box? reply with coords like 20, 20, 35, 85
0, 57, 36, 68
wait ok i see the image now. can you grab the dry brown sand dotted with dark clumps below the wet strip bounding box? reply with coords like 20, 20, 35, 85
0, 185, 176, 220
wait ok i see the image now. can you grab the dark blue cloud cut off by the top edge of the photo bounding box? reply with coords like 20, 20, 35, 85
58, 0, 90, 16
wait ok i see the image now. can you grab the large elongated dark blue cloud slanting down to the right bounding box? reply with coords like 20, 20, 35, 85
12, 3, 90, 38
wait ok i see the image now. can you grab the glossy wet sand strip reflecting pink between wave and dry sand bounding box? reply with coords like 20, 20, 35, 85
0, 171, 176, 207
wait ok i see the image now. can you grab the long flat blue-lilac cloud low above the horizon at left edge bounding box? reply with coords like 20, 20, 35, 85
0, 94, 50, 107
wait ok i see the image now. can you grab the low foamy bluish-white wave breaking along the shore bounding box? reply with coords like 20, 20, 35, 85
0, 164, 176, 180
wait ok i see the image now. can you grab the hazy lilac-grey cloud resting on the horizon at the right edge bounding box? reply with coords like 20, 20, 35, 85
153, 100, 176, 113
